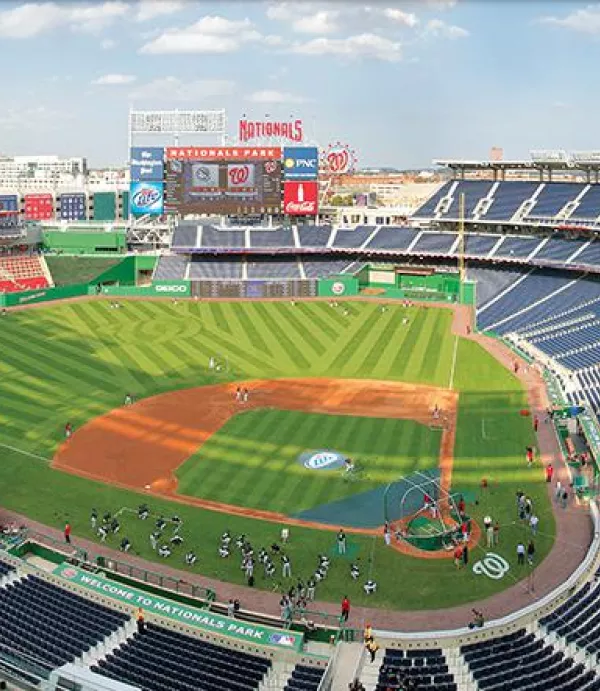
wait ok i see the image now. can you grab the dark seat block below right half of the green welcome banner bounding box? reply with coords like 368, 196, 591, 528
91, 624, 271, 691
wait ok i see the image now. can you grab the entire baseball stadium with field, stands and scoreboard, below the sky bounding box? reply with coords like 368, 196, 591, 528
0, 16, 600, 691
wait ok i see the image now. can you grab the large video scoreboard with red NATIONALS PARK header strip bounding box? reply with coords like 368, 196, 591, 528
165, 147, 281, 216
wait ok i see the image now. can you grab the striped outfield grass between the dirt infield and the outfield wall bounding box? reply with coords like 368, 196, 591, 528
0, 301, 452, 457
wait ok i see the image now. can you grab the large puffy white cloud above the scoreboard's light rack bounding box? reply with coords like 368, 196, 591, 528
140, 16, 262, 55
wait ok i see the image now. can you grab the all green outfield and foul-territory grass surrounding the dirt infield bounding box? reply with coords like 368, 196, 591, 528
0, 301, 554, 609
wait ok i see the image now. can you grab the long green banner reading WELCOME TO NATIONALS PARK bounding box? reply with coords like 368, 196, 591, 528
53, 564, 303, 651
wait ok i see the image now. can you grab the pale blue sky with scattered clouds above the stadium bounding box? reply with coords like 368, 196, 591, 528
0, 0, 600, 168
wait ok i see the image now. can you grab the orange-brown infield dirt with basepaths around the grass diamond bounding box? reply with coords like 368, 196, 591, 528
53, 378, 458, 554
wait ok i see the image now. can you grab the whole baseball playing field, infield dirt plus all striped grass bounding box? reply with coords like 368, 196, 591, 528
0, 300, 554, 609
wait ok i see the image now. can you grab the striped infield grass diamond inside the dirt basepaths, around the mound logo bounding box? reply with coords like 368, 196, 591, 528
177, 410, 441, 515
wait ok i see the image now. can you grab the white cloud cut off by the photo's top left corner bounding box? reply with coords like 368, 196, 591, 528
0, 2, 129, 38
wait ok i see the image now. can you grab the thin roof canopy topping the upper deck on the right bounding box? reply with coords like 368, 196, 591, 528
433, 149, 600, 171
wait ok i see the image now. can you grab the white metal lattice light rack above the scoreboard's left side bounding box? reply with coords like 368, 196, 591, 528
129, 110, 227, 148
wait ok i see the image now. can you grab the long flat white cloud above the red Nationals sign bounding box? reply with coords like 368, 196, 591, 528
292, 33, 402, 62
